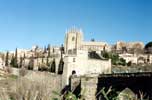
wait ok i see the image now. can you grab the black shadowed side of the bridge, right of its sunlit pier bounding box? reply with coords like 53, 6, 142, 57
97, 73, 152, 100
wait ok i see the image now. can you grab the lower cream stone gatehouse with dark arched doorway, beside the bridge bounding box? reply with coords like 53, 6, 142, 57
62, 50, 111, 86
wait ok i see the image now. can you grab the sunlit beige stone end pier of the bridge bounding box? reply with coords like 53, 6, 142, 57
70, 76, 98, 100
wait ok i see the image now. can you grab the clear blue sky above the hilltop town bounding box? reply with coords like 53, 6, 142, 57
0, 0, 152, 51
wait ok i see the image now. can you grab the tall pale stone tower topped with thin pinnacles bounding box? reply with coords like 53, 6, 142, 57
64, 27, 83, 53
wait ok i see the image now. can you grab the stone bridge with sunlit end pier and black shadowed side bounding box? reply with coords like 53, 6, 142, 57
71, 72, 152, 100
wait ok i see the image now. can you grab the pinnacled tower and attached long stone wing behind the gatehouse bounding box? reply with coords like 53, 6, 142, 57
64, 28, 110, 53
